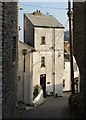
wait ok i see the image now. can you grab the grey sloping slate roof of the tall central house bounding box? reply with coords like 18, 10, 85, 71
25, 13, 64, 28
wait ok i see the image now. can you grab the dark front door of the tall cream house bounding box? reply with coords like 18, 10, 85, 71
40, 74, 46, 96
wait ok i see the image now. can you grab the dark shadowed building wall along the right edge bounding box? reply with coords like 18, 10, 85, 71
73, 1, 86, 118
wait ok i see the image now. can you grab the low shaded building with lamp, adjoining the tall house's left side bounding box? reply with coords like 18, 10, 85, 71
17, 42, 33, 104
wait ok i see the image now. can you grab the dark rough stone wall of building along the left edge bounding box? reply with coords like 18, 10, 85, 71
0, 2, 18, 118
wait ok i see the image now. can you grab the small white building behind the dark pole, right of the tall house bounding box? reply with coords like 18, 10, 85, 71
63, 49, 79, 91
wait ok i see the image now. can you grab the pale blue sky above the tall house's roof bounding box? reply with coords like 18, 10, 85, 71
19, 0, 68, 41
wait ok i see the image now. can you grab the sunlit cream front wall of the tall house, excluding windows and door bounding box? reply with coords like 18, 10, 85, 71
33, 27, 64, 96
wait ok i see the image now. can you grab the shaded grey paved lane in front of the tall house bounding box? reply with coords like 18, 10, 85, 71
24, 93, 78, 118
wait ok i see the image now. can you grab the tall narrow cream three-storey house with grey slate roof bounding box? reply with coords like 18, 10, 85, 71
24, 10, 64, 96
